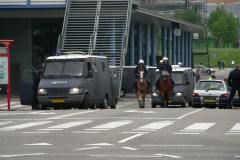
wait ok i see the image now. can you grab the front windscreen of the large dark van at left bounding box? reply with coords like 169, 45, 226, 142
44, 61, 84, 76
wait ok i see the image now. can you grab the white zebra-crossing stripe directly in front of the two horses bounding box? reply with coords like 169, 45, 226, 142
135, 121, 174, 131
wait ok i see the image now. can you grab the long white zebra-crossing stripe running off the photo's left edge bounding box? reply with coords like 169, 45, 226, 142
0, 121, 52, 131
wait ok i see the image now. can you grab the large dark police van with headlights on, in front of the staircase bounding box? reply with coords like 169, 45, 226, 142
20, 52, 118, 109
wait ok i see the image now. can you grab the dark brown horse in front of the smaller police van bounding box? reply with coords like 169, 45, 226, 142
158, 73, 173, 107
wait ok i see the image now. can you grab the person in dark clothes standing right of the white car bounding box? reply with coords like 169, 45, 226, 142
228, 64, 240, 108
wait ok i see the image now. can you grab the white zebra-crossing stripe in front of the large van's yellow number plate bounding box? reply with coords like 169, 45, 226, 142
40, 120, 92, 130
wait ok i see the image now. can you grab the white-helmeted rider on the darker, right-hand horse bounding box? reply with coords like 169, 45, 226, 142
156, 57, 174, 89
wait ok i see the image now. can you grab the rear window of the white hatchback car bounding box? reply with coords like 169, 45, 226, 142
196, 81, 225, 90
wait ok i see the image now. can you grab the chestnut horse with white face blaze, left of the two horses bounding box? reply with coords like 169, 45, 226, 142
137, 70, 147, 108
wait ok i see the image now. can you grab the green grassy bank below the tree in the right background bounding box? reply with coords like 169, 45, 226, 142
193, 48, 240, 67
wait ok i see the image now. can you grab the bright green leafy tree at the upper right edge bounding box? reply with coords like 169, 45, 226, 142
208, 6, 239, 48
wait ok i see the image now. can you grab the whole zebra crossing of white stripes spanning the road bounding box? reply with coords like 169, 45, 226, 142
0, 119, 240, 135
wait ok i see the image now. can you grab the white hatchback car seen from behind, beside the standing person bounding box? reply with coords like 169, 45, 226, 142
192, 80, 229, 108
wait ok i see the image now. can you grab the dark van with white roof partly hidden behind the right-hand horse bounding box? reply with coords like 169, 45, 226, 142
151, 65, 196, 108
